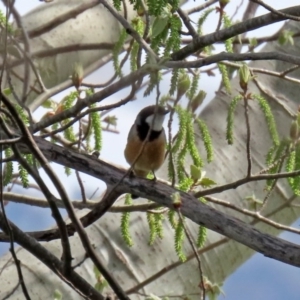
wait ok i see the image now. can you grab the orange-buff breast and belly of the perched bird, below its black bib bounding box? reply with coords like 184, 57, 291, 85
124, 130, 166, 177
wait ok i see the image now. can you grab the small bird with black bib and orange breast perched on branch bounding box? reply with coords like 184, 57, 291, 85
124, 105, 170, 199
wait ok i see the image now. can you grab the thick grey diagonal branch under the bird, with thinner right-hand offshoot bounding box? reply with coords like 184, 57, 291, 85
4, 137, 300, 266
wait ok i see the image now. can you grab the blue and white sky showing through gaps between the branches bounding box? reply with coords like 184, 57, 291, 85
0, 0, 300, 300
